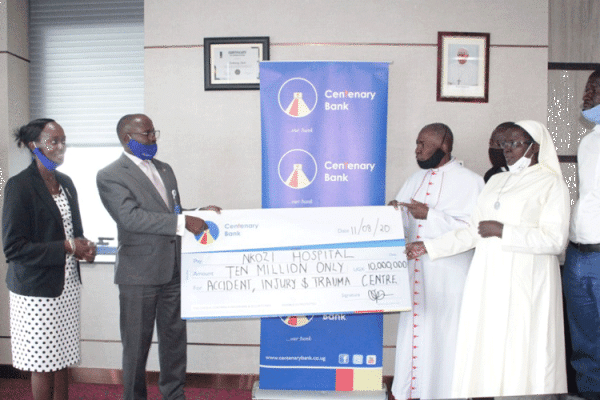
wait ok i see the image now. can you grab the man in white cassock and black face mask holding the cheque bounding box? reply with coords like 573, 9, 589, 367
389, 123, 484, 399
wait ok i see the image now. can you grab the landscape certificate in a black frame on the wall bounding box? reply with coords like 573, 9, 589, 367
204, 36, 269, 90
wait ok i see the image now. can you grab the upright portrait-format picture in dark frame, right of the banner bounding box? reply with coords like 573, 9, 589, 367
437, 32, 490, 103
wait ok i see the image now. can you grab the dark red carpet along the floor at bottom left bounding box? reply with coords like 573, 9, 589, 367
0, 379, 252, 400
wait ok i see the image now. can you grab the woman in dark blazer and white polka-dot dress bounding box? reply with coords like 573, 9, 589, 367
2, 119, 96, 400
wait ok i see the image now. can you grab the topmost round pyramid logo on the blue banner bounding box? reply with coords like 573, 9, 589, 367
278, 78, 318, 118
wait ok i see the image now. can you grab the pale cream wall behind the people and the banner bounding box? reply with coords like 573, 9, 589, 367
0, 0, 548, 375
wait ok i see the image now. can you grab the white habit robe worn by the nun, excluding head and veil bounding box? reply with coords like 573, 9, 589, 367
425, 164, 569, 398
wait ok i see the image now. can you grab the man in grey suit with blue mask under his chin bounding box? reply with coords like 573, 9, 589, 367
96, 114, 220, 400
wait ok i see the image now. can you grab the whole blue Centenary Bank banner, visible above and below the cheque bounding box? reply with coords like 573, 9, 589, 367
259, 61, 388, 391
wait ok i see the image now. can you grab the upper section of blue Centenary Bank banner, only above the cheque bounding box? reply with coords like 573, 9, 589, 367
260, 61, 388, 208
